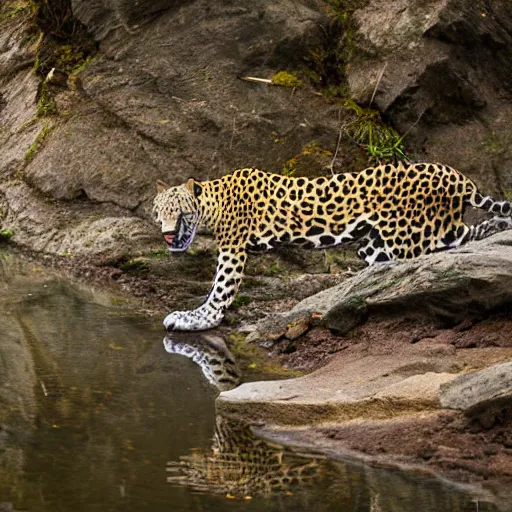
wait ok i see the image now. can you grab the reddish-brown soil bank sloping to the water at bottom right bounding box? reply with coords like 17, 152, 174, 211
318, 410, 512, 484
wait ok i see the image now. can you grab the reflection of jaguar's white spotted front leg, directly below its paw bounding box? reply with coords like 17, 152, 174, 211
164, 333, 241, 391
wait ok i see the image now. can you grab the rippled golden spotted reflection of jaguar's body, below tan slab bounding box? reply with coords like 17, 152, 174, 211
167, 415, 325, 498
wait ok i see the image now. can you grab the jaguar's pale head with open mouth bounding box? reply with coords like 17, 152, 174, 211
153, 179, 201, 252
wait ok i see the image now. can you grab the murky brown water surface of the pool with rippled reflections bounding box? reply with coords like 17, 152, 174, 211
0, 252, 504, 512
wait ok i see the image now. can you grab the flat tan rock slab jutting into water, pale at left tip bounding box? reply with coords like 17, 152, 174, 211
216, 354, 456, 426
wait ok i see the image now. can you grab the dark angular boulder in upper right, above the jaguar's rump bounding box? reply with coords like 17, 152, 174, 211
346, 0, 512, 193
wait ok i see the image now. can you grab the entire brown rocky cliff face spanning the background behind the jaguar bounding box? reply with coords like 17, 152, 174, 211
0, 0, 512, 261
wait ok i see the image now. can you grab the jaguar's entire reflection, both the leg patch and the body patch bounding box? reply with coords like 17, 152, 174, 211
164, 333, 320, 498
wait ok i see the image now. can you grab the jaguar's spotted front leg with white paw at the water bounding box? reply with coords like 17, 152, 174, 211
164, 248, 247, 331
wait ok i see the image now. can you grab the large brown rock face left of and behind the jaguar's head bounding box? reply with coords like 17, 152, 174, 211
0, 0, 339, 261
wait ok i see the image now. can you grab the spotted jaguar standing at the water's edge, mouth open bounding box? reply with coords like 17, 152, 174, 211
153, 162, 512, 331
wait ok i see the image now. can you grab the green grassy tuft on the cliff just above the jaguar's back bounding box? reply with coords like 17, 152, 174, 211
343, 100, 407, 163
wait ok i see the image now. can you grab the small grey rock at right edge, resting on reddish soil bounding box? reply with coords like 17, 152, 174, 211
440, 362, 512, 416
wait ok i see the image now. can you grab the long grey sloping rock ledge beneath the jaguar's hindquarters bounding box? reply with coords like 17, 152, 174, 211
247, 232, 512, 346
